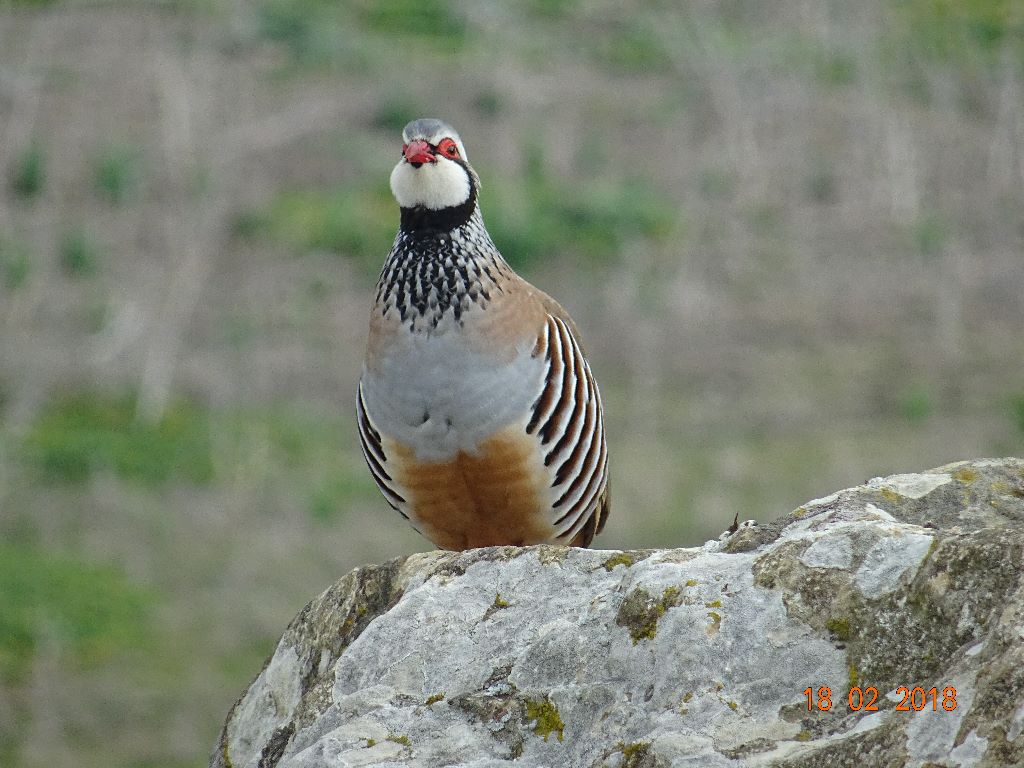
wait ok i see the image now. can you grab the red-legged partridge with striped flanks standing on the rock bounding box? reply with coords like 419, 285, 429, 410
357, 119, 609, 550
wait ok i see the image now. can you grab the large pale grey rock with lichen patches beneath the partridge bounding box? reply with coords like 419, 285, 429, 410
210, 459, 1024, 768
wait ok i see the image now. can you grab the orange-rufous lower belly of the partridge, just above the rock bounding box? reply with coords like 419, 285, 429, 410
387, 424, 554, 550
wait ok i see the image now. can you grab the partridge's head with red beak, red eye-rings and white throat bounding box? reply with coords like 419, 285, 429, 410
391, 118, 479, 211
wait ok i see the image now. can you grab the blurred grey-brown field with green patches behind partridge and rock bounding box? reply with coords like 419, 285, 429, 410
0, 0, 1024, 768
